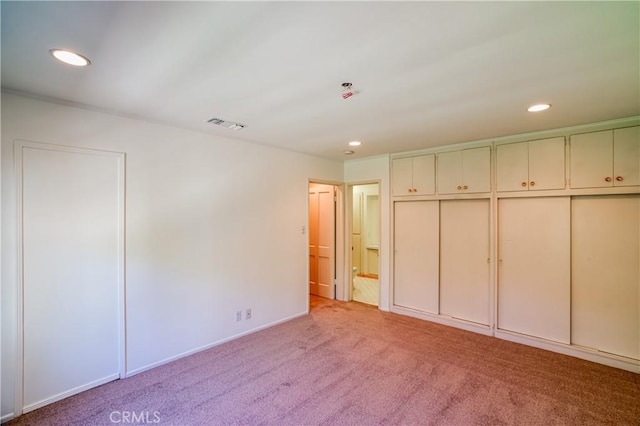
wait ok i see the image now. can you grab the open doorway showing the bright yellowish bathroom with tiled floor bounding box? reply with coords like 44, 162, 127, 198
350, 183, 380, 306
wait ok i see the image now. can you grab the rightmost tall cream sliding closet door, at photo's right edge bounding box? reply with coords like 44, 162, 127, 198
571, 195, 640, 359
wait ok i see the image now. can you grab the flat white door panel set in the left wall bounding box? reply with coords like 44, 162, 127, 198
16, 143, 124, 412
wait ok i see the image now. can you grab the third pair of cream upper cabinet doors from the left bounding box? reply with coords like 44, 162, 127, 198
496, 137, 565, 191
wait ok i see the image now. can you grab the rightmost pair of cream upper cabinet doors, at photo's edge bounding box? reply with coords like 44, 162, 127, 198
571, 126, 640, 188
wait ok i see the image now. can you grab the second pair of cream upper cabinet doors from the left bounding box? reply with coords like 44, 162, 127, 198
438, 146, 491, 194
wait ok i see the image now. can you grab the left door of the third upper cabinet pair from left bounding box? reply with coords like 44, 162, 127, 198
496, 142, 529, 191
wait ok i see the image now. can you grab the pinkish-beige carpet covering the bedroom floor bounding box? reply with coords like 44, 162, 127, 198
8, 297, 640, 426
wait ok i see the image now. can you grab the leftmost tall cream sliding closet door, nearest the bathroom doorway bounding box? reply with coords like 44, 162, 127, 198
393, 201, 440, 314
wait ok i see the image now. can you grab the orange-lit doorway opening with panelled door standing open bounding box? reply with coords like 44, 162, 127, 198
309, 183, 336, 299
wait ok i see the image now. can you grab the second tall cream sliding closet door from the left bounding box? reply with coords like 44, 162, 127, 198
440, 200, 489, 325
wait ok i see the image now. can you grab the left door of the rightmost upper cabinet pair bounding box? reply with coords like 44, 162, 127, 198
571, 130, 613, 188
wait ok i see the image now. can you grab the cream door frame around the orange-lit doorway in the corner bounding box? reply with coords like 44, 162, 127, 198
305, 178, 346, 306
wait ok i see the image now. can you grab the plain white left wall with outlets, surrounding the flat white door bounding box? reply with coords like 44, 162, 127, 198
2, 93, 343, 416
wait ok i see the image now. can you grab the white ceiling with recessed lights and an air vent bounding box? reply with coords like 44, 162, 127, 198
1, 1, 640, 160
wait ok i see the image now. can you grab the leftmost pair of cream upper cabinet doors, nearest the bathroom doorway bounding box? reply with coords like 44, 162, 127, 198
392, 154, 435, 196
